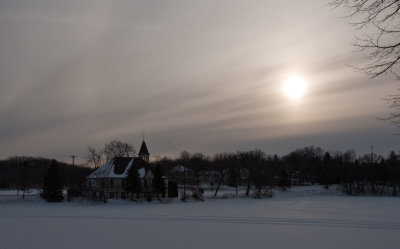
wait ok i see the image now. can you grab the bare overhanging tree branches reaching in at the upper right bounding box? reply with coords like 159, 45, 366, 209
331, 0, 400, 126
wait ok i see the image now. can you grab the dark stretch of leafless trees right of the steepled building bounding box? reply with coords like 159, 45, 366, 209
153, 146, 400, 198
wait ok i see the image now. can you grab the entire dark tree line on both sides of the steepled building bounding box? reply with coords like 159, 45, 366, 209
0, 146, 400, 199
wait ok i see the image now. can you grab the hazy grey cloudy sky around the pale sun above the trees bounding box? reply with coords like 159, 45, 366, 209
0, 0, 400, 160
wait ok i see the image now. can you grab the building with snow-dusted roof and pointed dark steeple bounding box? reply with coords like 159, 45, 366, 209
86, 141, 168, 200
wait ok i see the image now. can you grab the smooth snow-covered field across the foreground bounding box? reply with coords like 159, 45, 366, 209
0, 187, 400, 249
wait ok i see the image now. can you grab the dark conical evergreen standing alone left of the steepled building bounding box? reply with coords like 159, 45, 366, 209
41, 159, 64, 202
